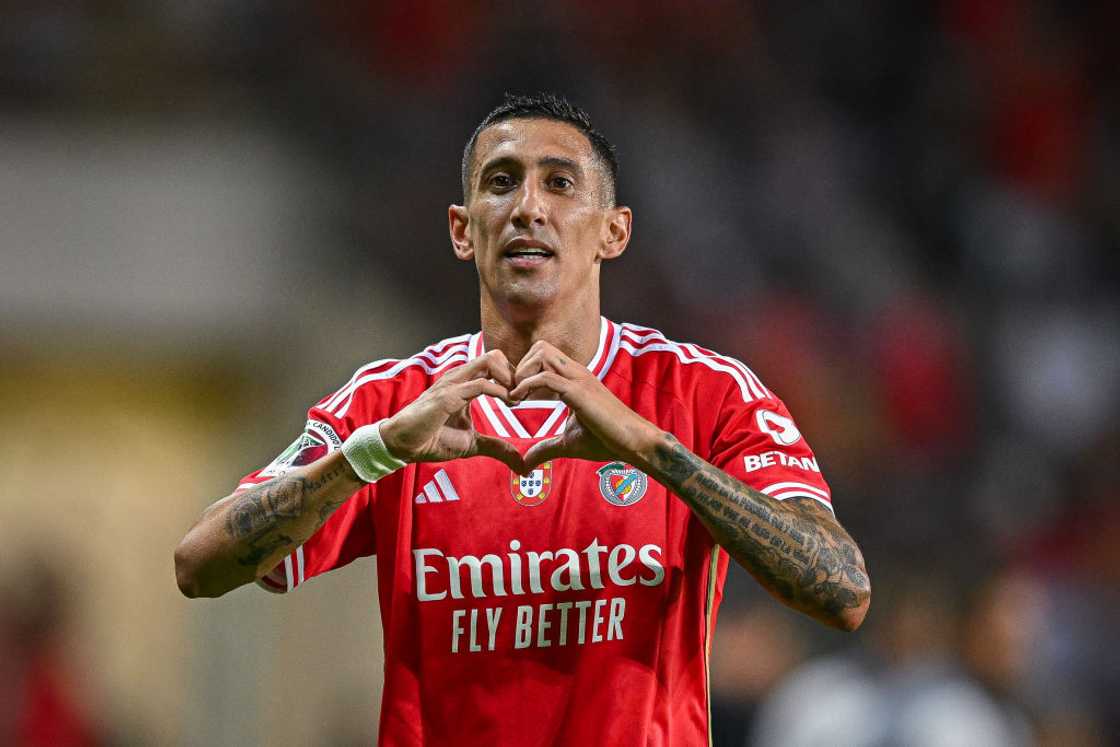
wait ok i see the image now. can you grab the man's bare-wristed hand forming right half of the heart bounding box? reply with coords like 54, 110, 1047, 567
510, 340, 662, 474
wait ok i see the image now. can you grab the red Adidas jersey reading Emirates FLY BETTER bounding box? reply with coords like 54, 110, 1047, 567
242, 319, 831, 747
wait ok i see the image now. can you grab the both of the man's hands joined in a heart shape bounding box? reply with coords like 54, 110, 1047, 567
381, 340, 661, 475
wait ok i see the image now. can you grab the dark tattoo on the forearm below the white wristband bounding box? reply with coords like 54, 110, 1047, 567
225, 465, 346, 567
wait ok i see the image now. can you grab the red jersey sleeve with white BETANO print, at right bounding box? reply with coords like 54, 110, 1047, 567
709, 389, 833, 511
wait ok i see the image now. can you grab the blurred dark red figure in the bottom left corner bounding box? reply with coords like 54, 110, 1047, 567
0, 560, 102, 747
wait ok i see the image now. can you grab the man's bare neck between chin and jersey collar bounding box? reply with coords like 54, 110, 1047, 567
482, 299, 599, 366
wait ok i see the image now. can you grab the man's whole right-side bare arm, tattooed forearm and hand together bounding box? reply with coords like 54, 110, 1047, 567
510, 342, 871, 631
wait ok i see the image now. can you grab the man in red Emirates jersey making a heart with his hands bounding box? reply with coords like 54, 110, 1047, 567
176, 90, 870, 745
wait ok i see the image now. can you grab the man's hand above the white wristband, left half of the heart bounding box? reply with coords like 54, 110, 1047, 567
381, 349, 524, 473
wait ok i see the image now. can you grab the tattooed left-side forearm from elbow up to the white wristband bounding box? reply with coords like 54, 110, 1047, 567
175, 451, 365, 598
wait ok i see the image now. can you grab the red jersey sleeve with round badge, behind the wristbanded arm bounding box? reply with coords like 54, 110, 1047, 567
237, 403, 376, 594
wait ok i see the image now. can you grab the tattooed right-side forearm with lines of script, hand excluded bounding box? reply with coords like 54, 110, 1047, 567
653, 436, 870, 616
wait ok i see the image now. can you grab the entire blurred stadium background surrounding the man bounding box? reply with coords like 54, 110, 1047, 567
0, 0, 1120, 747
